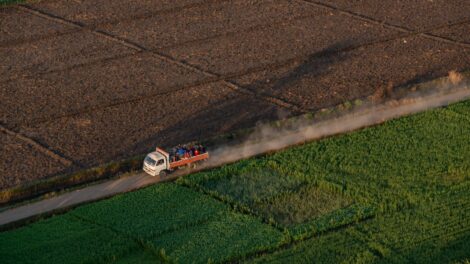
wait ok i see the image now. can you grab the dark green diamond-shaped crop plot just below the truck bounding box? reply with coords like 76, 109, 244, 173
71, 183, 228, 238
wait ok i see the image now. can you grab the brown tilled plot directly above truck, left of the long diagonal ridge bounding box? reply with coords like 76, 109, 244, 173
18, 83, 277, 166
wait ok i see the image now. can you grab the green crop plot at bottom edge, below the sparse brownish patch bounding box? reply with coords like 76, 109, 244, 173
152, 213, 283, 263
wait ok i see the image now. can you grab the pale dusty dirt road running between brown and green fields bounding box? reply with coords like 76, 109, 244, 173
0, 84, 470, 226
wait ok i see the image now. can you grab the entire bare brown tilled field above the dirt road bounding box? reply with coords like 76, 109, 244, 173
0, 0, 470, 188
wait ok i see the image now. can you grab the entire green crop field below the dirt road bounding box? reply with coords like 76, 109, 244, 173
0, 101, 470, 263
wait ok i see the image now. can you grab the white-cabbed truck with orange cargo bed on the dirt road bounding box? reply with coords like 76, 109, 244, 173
143, 147, 209, 177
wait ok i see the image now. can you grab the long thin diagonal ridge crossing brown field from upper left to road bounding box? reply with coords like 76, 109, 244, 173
17, 5, 307, 113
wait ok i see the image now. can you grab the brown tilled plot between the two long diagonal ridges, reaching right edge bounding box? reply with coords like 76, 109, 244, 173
229, 37, 470, 110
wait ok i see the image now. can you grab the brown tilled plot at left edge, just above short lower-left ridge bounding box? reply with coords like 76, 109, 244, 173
0, 53, 209, 127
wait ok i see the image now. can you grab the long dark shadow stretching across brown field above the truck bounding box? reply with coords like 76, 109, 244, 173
118, 42, 356, 156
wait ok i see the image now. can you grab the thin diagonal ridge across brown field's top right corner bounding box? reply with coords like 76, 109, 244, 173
296, 0, 470, 48
